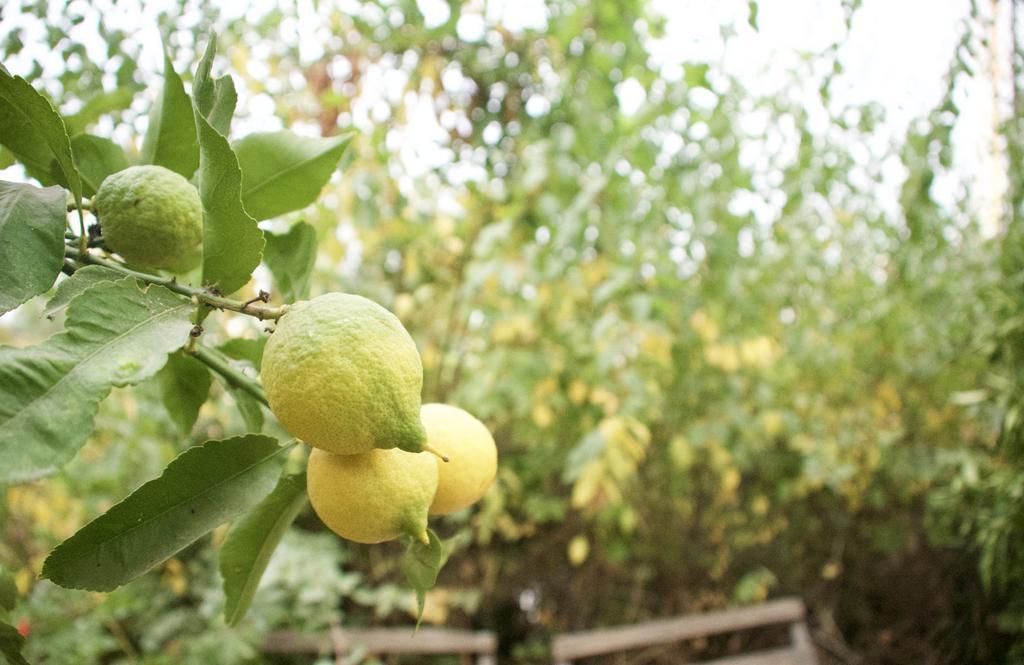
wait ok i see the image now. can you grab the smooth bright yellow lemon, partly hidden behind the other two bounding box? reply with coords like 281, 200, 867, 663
420, 404, 498, 514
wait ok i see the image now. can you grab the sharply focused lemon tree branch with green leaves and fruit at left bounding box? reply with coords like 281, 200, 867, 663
0, 29, 460, 643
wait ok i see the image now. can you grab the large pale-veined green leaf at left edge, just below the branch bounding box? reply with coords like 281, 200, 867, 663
0, 278, 193, 484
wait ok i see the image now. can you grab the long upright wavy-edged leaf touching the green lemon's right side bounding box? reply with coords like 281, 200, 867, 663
194, 109, 264, 294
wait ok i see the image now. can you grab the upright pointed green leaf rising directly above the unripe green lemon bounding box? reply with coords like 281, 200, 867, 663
141, 53, 200, 178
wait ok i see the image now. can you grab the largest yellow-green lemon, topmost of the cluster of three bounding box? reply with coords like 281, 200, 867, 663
261, 293, 427, 455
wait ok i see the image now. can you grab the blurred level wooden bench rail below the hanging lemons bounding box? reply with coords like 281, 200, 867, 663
263, 626, 498, 665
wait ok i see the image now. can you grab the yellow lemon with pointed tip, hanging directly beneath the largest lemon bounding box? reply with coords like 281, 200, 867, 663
306, 448, 437, 543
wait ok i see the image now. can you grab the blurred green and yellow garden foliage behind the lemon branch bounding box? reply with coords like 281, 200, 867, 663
0, 0, 1024, 664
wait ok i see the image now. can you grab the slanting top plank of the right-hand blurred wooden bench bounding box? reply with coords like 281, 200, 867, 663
551, 598, 804, 661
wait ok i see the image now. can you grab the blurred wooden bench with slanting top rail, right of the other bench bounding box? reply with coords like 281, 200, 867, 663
551, 598, 817, 665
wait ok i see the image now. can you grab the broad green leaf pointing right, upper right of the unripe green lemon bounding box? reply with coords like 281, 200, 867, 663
234, 131, 351, 219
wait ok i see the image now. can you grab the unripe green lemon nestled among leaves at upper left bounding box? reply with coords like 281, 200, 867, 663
93, 165, 203, 269
